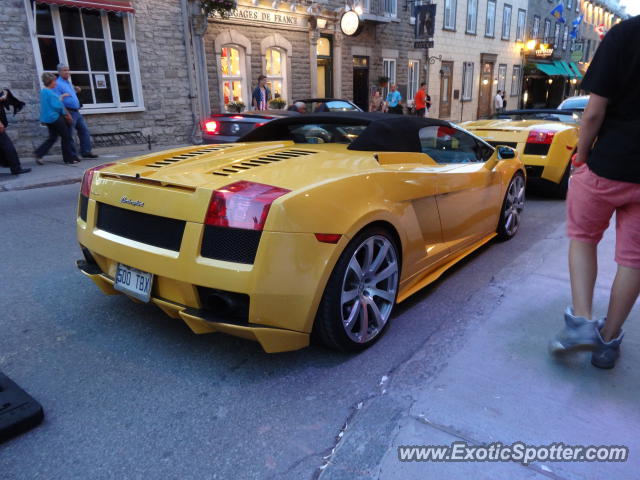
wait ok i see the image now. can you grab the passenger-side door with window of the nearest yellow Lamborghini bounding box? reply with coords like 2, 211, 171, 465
420, 126, 500, 252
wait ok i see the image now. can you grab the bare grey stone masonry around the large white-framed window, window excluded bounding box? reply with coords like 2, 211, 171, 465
0, 0, 193, 156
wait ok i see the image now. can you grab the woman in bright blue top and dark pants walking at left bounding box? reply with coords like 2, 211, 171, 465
34, 73, 80, 165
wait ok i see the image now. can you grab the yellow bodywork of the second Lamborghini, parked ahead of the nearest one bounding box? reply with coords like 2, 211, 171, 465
460, 119, 579, 183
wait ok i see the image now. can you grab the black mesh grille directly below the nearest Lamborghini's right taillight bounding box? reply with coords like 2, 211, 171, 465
200, 225, 262, 265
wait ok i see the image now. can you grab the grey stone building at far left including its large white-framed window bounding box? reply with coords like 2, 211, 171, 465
0, 0, 197, 155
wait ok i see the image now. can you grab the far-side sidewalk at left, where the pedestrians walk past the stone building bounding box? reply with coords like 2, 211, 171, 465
0, 145, 187, 193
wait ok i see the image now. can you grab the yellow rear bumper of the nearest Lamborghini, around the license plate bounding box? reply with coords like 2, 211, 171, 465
76, 199, 349, 351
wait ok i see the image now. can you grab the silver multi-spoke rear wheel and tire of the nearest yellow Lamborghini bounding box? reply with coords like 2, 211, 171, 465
313, 227, 400, 351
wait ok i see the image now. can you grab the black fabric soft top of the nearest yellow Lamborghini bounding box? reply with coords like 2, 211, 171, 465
238, 112, 451, 152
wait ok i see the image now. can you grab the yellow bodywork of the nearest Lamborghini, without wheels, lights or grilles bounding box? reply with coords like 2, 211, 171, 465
77, 142, 524, 352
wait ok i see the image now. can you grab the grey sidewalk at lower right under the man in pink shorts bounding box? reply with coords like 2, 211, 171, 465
319, 224, 640, 480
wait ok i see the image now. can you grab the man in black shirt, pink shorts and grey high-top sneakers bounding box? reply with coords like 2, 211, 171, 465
550, 16, 640, 368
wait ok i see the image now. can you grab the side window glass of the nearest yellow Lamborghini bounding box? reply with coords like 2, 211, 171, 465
419, 125, 485, 163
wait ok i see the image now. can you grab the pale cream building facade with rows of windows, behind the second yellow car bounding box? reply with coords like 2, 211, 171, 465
428, 0, 528, 121
